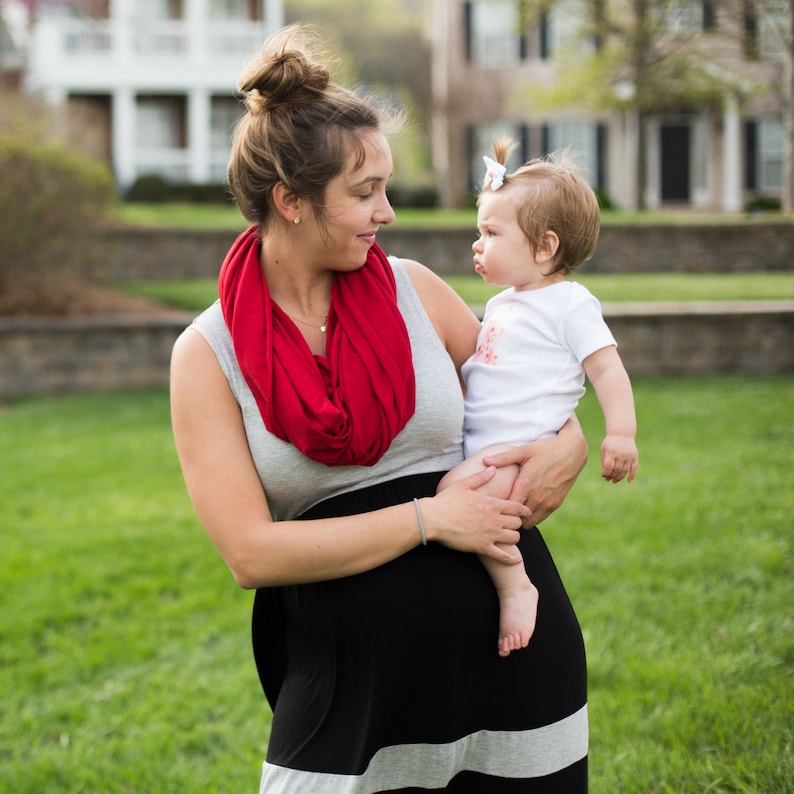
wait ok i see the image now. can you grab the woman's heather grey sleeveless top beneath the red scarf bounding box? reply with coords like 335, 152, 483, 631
192, 257, 463, 521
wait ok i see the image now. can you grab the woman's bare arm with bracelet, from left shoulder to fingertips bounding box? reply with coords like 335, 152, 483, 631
171, 329, 528, 588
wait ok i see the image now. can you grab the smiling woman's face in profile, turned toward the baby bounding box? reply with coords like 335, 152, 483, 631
314, 132, 394, 271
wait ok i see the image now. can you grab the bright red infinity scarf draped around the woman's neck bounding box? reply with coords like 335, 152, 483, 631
218, 226, 416, 466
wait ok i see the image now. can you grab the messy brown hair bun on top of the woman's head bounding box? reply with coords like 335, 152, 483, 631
240, 25, 330, 113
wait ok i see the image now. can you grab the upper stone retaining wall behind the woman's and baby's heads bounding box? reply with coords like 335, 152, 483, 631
96, 222, 794, 281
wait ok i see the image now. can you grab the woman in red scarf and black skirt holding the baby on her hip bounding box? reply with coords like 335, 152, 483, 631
172, 28, 587, 794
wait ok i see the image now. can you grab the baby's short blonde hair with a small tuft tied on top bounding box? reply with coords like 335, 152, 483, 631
478, 136, 601, 274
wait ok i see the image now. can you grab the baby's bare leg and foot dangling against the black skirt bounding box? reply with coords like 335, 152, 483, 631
438, 444, 538, 656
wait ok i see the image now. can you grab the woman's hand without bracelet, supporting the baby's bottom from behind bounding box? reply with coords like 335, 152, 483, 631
483, 417, 587, 524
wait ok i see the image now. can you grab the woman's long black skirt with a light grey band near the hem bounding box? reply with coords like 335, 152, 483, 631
252, 472, 587, 794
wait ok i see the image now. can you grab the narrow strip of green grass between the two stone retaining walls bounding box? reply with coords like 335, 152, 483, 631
117, 272, 794, 311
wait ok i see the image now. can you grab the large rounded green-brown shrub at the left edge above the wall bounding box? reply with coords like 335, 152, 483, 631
0, 135, 116, 314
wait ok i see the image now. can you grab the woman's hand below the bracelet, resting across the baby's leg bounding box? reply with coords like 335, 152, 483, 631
419, 466, 531, 565
